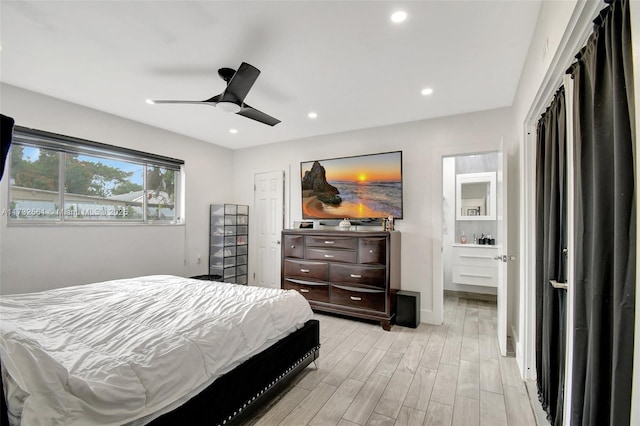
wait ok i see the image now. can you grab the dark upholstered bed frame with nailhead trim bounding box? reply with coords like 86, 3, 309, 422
0, 320, 320, 426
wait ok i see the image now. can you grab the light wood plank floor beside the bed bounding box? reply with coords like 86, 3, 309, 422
246, 296, 536, 426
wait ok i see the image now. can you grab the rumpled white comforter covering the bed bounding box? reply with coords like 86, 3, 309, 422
0, 275, 312, 426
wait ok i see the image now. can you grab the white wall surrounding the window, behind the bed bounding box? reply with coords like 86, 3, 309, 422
0, 84, 233, 294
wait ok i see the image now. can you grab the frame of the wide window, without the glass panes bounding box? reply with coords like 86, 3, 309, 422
4, 126, 185, 226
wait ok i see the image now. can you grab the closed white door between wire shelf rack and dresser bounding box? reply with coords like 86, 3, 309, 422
252, 171, 284, 288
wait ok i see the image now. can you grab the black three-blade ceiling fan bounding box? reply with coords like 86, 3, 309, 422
147, 62, 280, 126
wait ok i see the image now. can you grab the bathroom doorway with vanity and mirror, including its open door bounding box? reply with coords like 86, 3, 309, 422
442, 151, 508, 355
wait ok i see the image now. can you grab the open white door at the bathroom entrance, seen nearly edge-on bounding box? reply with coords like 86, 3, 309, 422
496, 143, 510, 356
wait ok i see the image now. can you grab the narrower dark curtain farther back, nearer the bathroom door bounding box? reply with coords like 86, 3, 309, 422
536, 88, 567, 425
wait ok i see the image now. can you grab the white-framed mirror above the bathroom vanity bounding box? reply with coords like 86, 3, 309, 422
456, 172, 496, 220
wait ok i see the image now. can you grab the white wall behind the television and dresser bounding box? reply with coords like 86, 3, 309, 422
233, 108, 513, 322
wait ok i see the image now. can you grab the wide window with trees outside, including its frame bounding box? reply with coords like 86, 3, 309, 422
6, 127, 184, 224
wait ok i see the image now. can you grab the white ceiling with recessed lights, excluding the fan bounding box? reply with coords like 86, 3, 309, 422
0, 0, 540, 149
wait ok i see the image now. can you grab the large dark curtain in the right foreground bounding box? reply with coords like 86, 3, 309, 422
570, 0, 636, 426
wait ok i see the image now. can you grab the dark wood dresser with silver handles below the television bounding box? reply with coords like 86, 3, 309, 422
281, 229, 400, 330
